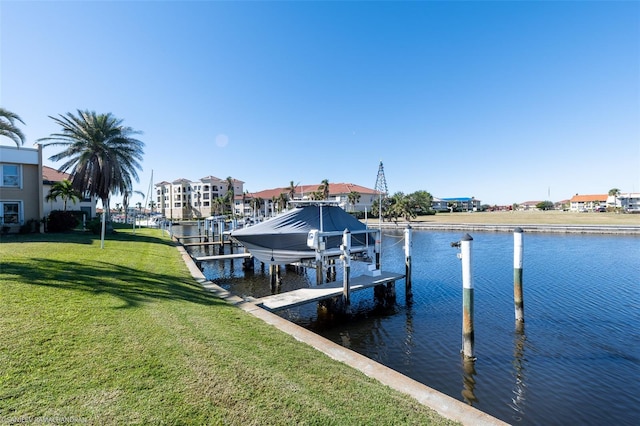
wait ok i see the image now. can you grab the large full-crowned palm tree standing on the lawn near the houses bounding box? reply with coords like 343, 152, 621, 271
38, 110, 144, 248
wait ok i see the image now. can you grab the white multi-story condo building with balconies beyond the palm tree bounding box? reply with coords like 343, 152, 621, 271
155, 176, 244, 220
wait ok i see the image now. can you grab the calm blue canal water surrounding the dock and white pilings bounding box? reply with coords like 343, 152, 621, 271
181, 225, 640, 425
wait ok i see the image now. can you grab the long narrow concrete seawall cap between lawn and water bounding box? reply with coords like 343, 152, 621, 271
176, 245, 508, 426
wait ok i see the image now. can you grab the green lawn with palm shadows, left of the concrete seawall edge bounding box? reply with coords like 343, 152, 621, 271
0, 229, 460, 425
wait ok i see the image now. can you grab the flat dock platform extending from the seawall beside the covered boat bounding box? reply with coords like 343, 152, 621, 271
255, 271, 405, 311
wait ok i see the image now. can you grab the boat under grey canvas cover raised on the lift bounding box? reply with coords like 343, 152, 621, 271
231, 205, 373, 264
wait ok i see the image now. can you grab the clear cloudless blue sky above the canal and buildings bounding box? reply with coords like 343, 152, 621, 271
0, 0, 640, 204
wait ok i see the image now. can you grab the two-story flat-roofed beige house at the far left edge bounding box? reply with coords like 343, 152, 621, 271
0, 145, 44, 233
